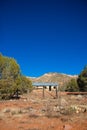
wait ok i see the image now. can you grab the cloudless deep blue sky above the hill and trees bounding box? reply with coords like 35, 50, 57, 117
0, 0, 87, 76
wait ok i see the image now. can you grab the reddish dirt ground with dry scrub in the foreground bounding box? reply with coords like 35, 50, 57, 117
0, 90, 87, 130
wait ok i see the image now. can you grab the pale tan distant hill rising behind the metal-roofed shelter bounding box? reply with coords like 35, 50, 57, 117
29, 72, 78, 86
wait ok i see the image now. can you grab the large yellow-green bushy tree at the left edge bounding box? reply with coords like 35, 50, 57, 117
0, 54, 32, 98
